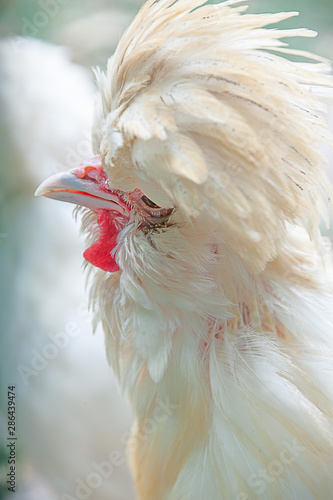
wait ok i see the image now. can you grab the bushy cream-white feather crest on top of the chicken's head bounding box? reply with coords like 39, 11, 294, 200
92, 0, 333, 271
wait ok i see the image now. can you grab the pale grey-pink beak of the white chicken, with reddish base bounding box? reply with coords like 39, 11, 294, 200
35, 161, 129, 215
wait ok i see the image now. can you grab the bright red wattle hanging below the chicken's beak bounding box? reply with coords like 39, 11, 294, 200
83, 210, 119, 273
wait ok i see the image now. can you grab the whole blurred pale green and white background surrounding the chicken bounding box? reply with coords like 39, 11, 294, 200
0, 0, 333, 500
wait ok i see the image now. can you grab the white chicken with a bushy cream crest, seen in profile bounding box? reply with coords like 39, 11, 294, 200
37, 0, 333, 500
